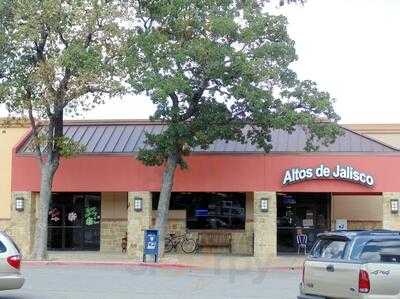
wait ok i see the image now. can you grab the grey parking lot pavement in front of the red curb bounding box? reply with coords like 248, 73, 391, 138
0, 266, 300, 299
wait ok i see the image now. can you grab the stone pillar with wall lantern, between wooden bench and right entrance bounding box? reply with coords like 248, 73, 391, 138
254, 192, 277, 261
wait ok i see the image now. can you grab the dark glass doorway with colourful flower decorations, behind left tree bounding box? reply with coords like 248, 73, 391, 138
47, 193, 101, 250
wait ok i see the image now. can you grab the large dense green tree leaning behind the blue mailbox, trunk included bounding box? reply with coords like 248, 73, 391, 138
124, 0, 339, 253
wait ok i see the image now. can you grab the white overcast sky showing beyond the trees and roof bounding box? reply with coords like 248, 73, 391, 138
0, 0, 400, 123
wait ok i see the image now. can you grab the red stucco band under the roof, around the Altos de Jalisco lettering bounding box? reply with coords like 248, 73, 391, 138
12, 153, 400, 194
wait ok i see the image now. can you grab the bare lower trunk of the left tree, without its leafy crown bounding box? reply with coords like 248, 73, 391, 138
32, 161, 58, 260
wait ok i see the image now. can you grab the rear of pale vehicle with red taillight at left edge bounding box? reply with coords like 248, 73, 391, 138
0, 232, 25, 291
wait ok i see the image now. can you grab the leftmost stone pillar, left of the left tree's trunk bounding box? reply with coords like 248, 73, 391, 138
9, 192, 37, 256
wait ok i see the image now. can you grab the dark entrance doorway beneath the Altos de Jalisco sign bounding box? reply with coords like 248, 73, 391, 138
277, 193, 331, 253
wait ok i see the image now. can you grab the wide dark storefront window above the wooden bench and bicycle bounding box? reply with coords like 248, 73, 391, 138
153, 192, 246, 230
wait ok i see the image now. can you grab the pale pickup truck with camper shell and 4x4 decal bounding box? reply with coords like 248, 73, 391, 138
297, 230, 400, 299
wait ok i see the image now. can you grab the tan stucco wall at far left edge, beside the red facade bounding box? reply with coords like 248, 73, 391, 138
0, 125, 28, 219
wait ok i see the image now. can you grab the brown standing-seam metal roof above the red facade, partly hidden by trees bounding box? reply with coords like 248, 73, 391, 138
19, 121, 399, 154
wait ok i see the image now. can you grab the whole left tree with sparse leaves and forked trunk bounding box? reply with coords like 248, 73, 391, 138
0, 0, 125, 259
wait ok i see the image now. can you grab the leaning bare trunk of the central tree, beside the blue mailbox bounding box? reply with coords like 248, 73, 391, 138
156, 153, 179, 257
